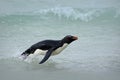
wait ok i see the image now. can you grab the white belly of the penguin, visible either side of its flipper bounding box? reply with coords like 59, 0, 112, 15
34, 43, 68, 55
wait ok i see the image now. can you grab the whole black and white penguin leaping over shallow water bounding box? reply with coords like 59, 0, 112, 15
21, 35, 78, 64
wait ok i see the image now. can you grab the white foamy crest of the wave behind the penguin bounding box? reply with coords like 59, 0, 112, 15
35, 7, 103, 21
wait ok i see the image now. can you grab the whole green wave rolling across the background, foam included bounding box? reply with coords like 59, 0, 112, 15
0, 7, 120, 24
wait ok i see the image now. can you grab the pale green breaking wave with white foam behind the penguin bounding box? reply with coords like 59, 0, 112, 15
0, 7, 120, 22
